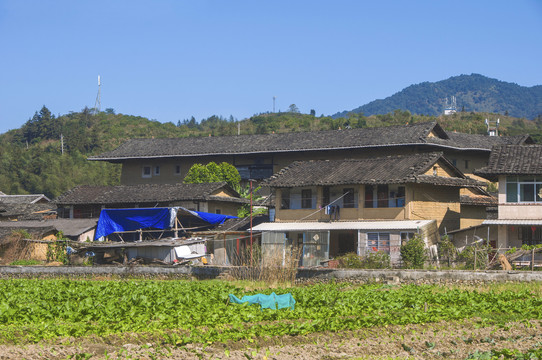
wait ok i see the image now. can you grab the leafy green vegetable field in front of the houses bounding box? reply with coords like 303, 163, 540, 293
0, 279, 542, 356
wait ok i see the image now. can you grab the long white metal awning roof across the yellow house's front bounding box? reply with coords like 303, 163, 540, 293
252, 220, 435, 231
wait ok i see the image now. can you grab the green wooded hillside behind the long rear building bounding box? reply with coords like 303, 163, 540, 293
0, 106, 542, 198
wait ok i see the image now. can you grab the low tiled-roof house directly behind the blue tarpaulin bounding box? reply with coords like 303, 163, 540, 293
55, 182, 248, 219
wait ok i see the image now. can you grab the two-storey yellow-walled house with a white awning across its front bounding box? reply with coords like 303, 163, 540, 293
253, 153, 484, 266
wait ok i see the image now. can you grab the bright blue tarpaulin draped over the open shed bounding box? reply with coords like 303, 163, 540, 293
94, 207, 236, 239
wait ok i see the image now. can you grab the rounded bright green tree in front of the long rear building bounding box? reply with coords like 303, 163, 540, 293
184, 161, 241, 189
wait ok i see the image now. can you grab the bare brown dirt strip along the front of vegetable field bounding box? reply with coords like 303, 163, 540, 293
0, 321, 542, 360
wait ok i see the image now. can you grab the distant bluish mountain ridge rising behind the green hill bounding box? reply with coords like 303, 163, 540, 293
333, 74, 542, 120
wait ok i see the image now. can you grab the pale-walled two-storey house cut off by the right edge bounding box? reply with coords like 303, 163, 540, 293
476, 145, 542, 248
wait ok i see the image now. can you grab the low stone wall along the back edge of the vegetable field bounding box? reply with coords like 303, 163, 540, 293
0, 266, 542, 284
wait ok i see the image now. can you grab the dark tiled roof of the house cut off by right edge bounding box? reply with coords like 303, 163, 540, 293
475, 145, 542, 180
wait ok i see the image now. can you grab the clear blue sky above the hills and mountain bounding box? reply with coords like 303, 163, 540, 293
0, 0, 542, 133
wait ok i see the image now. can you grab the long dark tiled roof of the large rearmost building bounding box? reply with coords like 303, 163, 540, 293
89, 122, 532, 161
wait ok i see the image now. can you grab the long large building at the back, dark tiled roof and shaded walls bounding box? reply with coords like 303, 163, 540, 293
89, 122, 532, 185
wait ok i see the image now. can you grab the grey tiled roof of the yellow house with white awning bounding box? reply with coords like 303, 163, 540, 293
264, 153, 485, 187
